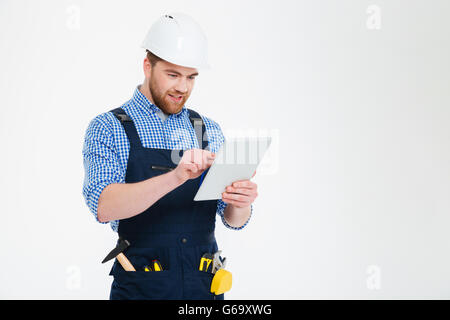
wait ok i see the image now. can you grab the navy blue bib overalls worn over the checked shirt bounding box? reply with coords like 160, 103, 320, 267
110, 108, 224, 300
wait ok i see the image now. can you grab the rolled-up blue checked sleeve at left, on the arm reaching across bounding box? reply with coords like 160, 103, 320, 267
83, 115, 125, 225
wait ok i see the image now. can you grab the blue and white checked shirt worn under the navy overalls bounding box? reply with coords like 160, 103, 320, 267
83, 86, 253, 232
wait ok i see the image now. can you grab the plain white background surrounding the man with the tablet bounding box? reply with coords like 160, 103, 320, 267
0, 0, 450, 299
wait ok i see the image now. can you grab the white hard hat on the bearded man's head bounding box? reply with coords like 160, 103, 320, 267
142, 12, 210, 69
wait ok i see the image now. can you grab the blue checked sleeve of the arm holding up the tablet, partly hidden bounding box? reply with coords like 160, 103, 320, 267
202, 116, 253, 230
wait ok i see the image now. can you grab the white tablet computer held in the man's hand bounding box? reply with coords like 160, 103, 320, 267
194, 137, 272, 201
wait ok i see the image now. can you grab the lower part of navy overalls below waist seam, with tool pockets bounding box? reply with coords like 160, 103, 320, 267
106, 232, 231, 300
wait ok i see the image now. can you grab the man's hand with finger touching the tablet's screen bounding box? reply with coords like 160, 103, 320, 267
174, 149, 216, 183
